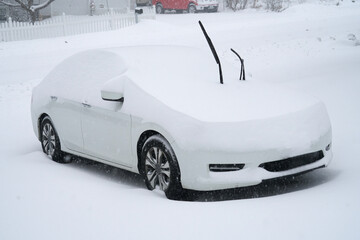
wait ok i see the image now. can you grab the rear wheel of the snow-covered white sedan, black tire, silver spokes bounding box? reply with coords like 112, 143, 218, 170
40, 117, 71, 163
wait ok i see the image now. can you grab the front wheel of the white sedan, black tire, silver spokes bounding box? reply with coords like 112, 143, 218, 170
141, 135, 183, 199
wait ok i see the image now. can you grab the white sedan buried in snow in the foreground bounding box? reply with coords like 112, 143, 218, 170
31, 46, 332, 198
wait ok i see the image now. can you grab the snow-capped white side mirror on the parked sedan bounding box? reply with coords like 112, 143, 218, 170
101, 76, 128, 102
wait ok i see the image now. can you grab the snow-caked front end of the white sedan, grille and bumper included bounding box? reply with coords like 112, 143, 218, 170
172, 101, 332, 191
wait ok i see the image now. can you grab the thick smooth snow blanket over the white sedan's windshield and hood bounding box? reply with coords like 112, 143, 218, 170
110, 46, 319, 122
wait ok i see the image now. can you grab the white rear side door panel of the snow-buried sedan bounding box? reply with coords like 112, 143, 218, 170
50, 95, 83, 152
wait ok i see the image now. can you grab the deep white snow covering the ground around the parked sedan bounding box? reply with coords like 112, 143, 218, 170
0, 0, 360, 239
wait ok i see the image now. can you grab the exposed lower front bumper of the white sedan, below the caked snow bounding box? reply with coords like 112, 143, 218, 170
174, 141, 333, 191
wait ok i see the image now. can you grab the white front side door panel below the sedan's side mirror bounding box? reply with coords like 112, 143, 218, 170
82, 98, 132, 167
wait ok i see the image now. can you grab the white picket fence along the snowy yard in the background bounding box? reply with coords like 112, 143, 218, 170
0, 7, 156, 42
